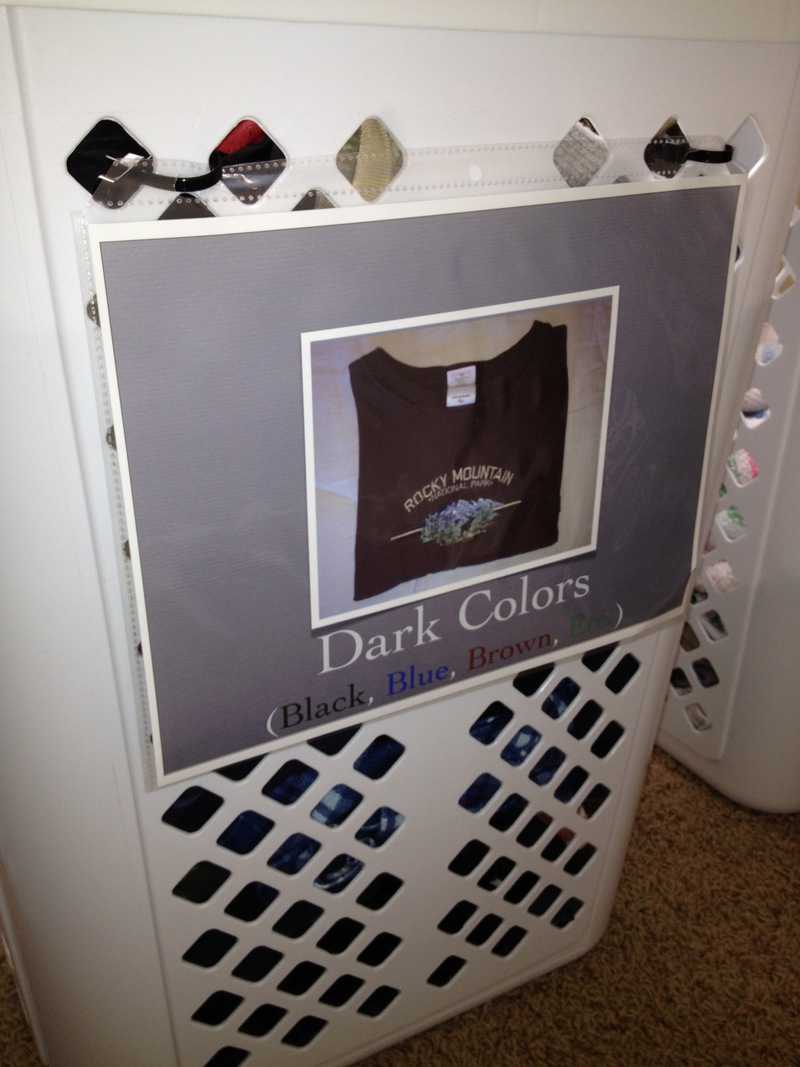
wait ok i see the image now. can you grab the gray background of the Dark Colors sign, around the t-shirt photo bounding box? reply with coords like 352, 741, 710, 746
101, 187, 739, 774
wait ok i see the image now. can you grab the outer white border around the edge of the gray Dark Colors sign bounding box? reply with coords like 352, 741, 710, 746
89, 174, 747, 786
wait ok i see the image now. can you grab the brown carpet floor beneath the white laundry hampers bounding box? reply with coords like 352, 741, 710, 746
0, 754, 800, 1067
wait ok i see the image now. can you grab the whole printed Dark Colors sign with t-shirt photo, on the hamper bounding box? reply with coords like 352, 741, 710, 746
91, 177, 740, 782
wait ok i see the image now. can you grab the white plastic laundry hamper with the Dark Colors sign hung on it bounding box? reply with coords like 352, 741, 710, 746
0, 7, 800, 1067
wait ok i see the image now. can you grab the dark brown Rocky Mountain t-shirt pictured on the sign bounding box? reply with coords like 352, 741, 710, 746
350, 321, 569, 601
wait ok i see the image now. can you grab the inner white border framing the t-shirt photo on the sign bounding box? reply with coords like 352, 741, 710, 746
300, 285, 620, 630
